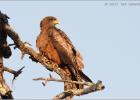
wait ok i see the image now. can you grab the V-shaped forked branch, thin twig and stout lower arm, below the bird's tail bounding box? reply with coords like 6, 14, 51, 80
33, 75, 104, 100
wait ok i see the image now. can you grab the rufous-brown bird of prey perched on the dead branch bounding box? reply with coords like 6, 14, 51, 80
36, 16, 92, 88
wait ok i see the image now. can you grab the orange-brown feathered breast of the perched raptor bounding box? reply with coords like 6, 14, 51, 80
36, 30, 61, 64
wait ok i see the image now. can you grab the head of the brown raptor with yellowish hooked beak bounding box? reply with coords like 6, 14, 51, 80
40, 16, 59, 28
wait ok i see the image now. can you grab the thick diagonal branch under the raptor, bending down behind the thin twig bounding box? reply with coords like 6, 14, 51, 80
5, 22, 74, 100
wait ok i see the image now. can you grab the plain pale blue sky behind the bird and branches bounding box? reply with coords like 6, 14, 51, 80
0, 1, 140, 99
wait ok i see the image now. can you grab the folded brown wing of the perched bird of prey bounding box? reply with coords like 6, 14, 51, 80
51, 28, 84, 69
